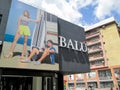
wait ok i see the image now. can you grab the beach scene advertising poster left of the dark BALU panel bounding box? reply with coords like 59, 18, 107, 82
0, 0, 59, 71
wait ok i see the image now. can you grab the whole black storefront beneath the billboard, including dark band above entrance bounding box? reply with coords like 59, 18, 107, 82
0, 68, 63, 90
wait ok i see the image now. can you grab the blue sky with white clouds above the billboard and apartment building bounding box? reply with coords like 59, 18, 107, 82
19, 0, 120, 27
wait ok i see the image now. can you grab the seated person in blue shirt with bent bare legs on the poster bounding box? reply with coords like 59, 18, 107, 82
21, 40, 56, 64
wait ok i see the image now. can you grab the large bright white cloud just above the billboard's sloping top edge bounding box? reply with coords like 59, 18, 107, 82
19, 0, 82, 23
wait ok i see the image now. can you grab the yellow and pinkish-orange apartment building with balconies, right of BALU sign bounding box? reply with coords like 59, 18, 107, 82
64, 17, 120, 90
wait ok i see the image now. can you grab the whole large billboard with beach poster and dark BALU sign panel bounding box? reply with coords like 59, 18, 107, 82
0, 0, 89, 73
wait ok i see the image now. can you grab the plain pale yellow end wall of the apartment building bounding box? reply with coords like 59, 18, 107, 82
100, 23, 120, 66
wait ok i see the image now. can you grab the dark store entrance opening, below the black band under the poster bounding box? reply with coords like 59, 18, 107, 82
0, 76, 58, 90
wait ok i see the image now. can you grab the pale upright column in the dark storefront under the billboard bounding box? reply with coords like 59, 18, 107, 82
33, 77, 42, 90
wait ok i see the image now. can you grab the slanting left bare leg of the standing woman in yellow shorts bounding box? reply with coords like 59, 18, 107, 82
5, 32, 21, 58
